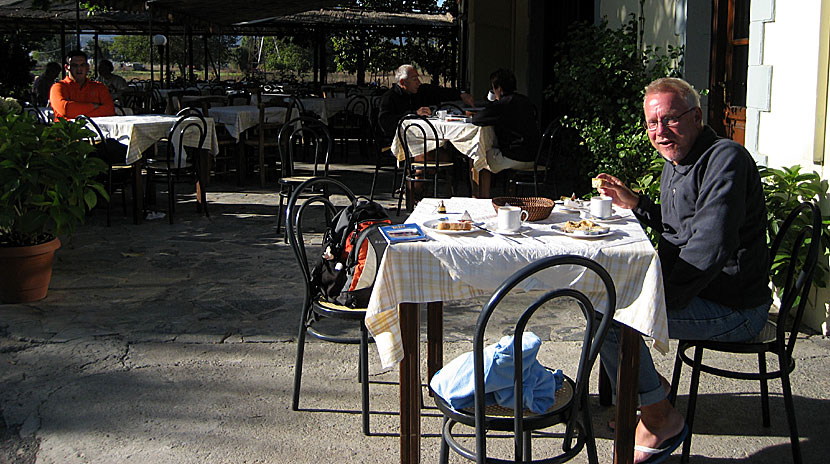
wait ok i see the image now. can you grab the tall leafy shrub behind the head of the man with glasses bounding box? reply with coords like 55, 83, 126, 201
546, 14, 683, 194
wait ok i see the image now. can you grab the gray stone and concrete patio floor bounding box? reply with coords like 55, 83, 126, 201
0, 160, 830, 464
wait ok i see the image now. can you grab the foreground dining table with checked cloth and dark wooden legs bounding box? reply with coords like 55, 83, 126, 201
365, 198, 669, 463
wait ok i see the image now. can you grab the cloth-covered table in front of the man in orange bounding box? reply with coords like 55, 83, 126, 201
92, 114, 219, 222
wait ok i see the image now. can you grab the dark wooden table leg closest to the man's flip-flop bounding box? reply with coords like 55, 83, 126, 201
614, 324, 641, 464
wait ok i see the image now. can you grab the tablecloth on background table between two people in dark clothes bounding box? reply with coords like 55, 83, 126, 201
392, 119, 501, 172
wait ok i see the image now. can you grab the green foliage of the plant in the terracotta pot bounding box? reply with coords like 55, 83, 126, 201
0, 106, 107, 246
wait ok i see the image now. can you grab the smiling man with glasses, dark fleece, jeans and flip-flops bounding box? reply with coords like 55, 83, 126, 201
597, 78, 772, 462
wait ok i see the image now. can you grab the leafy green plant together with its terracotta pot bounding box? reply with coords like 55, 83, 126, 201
0, 98, 107, 303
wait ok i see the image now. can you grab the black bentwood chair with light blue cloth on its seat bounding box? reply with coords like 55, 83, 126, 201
430, 255, 616, 464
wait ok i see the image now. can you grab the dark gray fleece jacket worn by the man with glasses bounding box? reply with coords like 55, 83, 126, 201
634, 126, 770, 311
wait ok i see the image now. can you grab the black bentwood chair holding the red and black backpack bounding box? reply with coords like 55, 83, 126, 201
285, 177, 384, 435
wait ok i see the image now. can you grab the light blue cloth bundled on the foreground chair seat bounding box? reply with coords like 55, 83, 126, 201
430, 332, 565, 413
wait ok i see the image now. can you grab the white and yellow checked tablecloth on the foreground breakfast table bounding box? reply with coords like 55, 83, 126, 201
366, 198, 669, 367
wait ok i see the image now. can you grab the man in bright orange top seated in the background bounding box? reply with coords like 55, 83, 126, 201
49, 50, 115, 121
